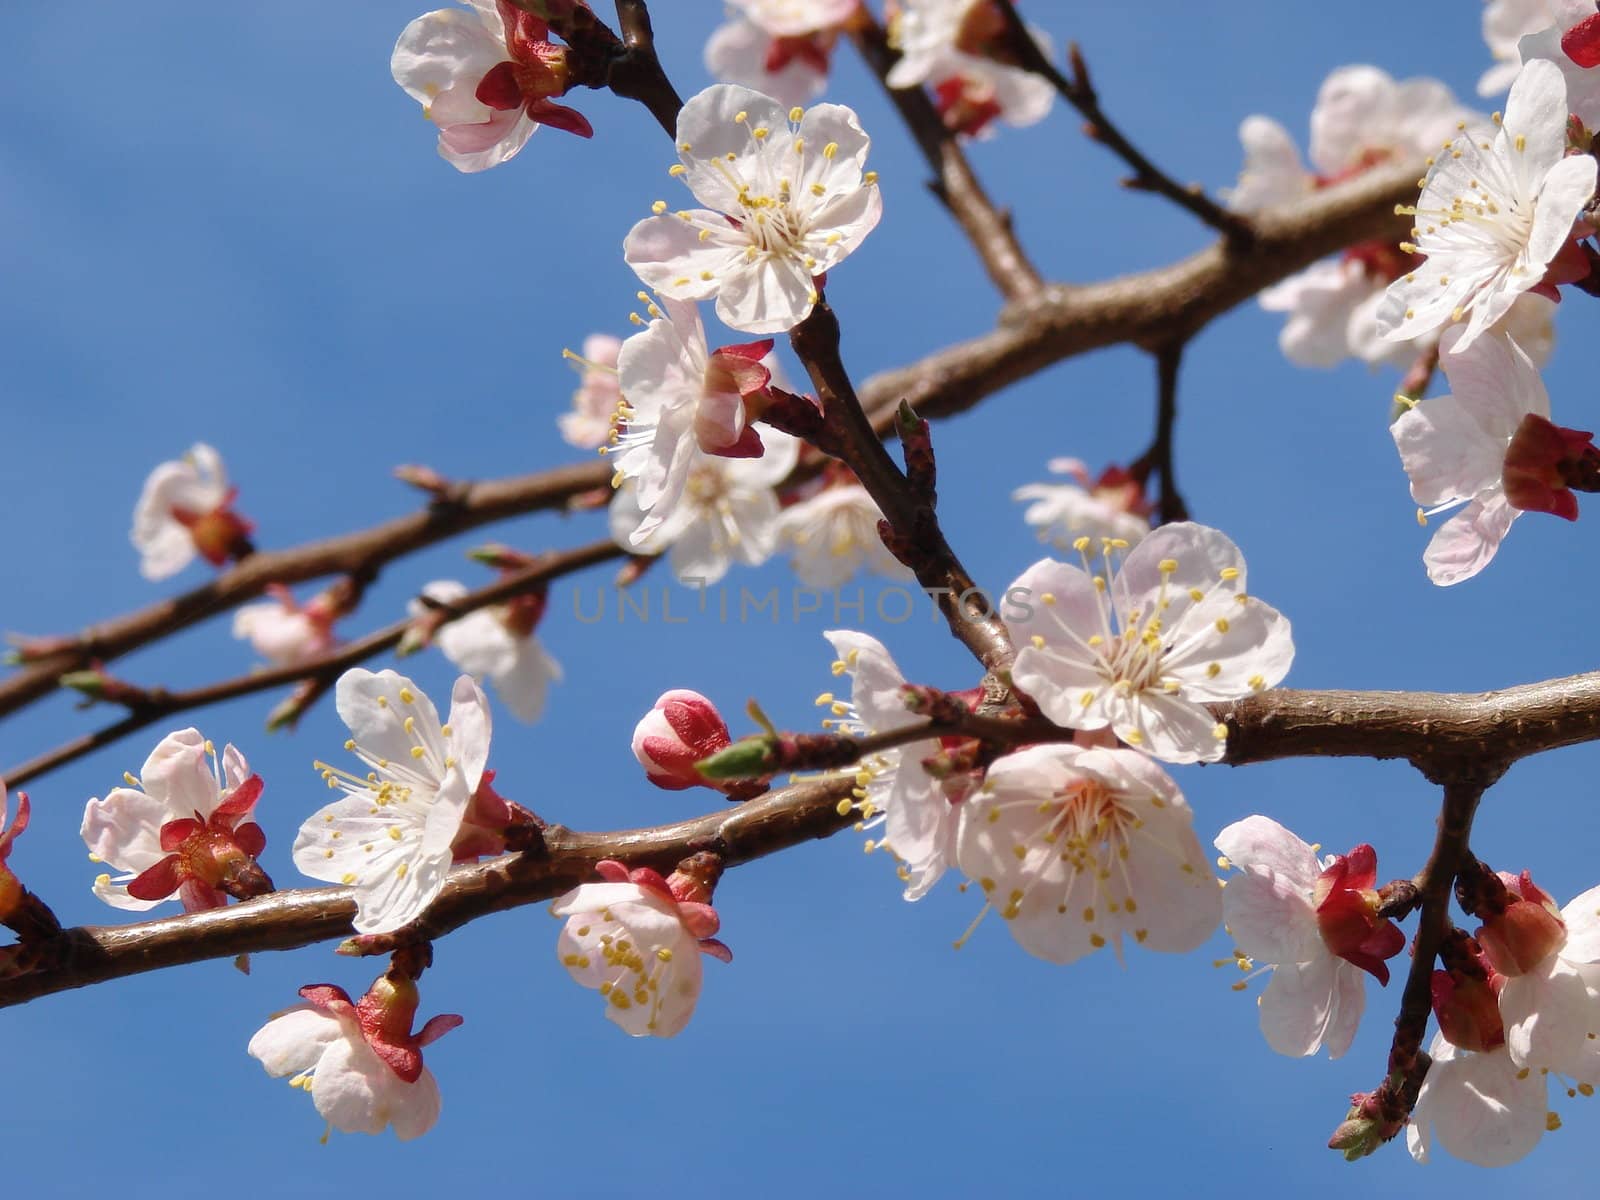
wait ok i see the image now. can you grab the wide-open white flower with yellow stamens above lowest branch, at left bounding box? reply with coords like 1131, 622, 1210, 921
294, 667, 491, 933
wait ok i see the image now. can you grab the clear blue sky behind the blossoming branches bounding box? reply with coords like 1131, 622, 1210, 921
0, 0, 1600, 1200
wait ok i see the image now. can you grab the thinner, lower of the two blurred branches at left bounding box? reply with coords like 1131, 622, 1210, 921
0, 541, 626, 786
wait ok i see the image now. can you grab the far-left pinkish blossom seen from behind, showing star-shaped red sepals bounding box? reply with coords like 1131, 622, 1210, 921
80, 730, 272, 912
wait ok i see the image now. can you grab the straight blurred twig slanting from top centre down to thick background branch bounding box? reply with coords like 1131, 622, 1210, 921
850, 8, 1045, 301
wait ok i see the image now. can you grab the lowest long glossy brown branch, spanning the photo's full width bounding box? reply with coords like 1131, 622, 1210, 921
18, 672, 1600, 1006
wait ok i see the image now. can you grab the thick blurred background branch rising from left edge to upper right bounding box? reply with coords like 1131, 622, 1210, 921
0, 163, 1422, 739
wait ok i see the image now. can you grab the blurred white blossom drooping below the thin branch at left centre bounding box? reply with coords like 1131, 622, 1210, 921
410, 579, 562, 723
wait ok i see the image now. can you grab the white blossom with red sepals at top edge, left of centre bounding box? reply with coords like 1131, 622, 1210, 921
389, 0, 594, 171
